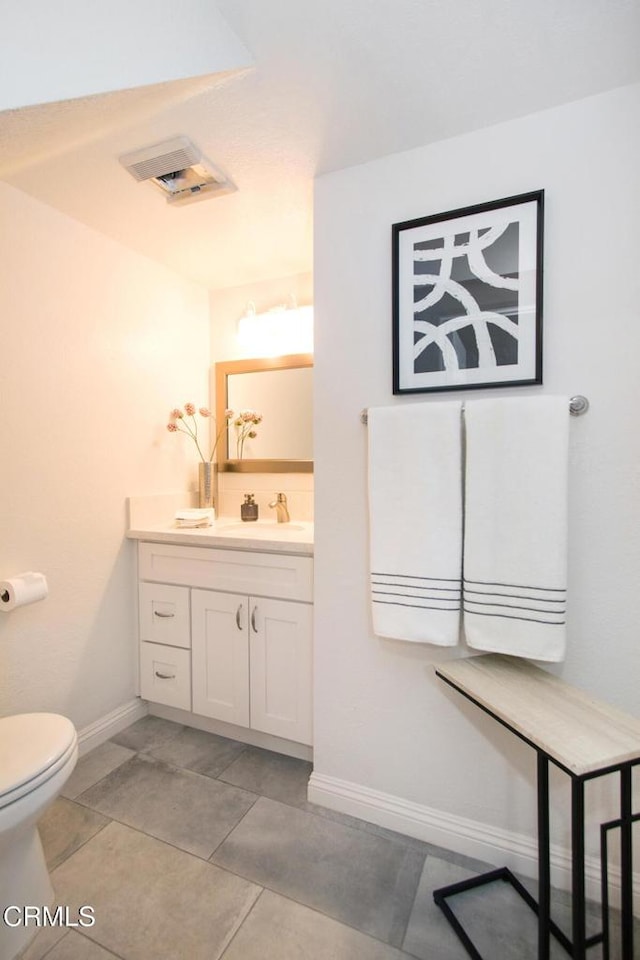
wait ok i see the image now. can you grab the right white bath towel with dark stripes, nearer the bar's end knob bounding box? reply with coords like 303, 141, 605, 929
463, 397, 569, 661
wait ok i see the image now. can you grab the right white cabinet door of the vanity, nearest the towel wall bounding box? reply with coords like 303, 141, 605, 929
248, 597, 313, 744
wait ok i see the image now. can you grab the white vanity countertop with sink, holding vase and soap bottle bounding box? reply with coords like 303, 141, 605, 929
127, 517, 313, 556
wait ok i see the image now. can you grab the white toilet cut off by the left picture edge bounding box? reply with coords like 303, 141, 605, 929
0, 713, 78, 960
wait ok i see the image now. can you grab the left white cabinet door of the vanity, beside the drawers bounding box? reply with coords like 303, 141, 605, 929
191, 590, 249, 727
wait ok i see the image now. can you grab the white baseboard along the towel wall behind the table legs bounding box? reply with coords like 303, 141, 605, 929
308, 772, 640, 911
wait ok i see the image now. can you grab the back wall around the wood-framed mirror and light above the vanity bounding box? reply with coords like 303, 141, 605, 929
209, 273, 313, 520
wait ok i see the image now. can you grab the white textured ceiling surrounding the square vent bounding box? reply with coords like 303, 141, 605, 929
0, 0, 640, 289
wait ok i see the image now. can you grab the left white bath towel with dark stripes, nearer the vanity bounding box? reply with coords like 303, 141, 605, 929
368, 403, 462, 646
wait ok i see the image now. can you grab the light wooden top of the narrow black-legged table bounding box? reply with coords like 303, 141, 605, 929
436, 653, 640, 776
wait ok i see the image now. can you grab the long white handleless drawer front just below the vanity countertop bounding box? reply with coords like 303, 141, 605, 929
138, 542, 313, 602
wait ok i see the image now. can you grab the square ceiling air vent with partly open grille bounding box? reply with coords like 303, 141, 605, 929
119, 137, 236, 203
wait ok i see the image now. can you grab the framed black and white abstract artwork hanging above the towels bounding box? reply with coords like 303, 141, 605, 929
392, 190, 544, 393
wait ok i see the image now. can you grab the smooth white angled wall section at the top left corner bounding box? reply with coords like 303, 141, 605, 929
0, 0, 252, 110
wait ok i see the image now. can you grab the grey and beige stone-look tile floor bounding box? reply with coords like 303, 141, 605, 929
23, 717, 636, 960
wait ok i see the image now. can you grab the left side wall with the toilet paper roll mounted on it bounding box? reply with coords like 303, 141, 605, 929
0, 183, 209, 728
